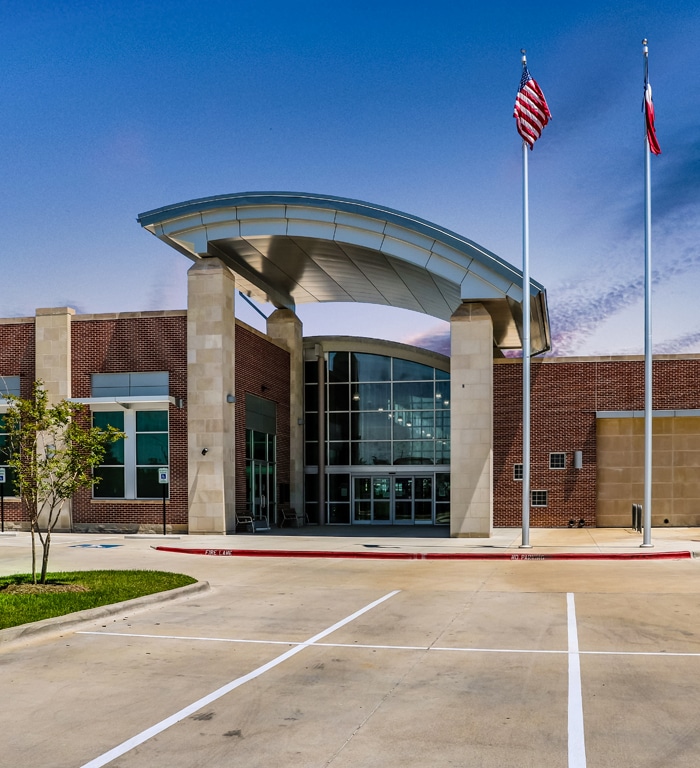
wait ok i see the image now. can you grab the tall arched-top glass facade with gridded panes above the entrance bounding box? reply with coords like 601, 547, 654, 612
304, 351, 450, 524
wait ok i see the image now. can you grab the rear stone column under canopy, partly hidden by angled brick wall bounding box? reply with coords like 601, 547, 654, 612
267, 309, 304, 515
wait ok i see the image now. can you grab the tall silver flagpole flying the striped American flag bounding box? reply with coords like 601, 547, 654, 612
520, 49, 531, 549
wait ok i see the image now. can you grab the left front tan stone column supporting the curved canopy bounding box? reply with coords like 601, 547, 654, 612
187, 259, 236, 534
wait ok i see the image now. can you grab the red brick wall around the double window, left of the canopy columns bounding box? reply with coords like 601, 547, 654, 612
71, 312, 187, 530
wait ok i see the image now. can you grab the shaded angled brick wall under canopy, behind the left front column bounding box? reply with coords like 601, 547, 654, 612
236, 324, 290, 510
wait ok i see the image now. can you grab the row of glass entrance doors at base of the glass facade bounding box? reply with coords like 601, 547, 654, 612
352, 475, 435, 525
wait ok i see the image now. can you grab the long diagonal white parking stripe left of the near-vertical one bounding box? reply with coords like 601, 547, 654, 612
81, 589, 401, 768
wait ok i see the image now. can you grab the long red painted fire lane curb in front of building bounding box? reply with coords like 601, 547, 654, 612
153, 547, 693, 560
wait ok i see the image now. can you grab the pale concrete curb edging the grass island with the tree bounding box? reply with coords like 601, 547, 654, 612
0, 581, 209, 652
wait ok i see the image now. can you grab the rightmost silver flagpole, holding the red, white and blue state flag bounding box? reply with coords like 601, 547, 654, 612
641, 39, 654, 547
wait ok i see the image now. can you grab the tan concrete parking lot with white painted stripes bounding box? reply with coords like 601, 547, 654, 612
0, 537, 700, 768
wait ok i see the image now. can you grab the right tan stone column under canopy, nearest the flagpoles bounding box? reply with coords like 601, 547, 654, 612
450, 304, 493, 537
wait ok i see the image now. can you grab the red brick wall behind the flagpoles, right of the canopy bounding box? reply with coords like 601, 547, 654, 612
494, 358, 700, 527
